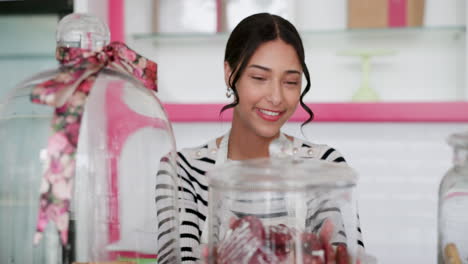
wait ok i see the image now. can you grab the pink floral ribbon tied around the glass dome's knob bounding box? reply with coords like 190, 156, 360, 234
31, 42, 157, 244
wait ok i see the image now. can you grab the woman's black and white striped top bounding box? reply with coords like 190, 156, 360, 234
156, 135, 364, 264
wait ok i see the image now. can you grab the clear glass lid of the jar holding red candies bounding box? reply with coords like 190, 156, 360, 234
208, 158, 357, 191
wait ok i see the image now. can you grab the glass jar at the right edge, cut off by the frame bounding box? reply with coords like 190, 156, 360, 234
438, 133, 468, 264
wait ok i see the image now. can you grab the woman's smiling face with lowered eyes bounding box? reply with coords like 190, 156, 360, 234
225, 39, 302, 138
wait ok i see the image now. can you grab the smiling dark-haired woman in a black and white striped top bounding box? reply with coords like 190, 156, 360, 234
156, 13, 363, 263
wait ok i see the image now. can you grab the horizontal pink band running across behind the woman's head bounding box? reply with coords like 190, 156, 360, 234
164, 102, 468, 122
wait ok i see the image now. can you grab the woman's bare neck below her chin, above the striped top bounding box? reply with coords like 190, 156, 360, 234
227, 117, 279, 160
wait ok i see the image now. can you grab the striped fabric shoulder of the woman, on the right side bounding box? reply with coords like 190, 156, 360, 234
292, 137, 346, 162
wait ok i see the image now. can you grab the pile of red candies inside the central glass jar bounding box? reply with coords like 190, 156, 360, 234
216, 216, 350, 264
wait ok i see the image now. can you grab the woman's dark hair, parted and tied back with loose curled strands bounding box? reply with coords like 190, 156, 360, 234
221, 13, 314, 127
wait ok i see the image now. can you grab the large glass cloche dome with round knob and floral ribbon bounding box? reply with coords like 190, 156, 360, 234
0, 14, 179, 264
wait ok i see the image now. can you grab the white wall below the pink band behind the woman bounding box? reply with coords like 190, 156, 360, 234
173, 123, 468, 264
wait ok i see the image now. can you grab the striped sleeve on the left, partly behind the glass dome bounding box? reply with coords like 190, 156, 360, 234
156, 152, 210, 264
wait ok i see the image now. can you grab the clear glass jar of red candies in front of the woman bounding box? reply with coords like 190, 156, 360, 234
208, 158, 357, 264
